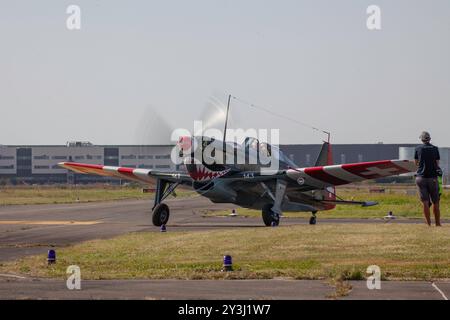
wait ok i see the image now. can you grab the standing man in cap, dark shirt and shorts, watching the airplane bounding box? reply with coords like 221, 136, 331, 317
414, 131, 441, 227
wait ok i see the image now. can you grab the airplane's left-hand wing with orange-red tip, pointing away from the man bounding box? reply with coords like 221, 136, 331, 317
58, 162, 192, 183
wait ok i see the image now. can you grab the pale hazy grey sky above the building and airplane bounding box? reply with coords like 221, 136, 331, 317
0, 0, 450, 146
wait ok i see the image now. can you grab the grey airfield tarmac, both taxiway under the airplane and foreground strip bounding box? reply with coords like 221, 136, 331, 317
0, 197, 450, 299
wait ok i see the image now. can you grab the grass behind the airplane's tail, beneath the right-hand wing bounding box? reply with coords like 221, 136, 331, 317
204, 188, 450, 219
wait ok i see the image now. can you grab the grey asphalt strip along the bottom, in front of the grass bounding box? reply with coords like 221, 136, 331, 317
0, 275, 450, 300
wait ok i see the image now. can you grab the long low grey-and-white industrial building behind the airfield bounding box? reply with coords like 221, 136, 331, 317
0, 141, 450, 184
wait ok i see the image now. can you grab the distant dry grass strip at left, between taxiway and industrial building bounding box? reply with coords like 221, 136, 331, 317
0, 185, 193, 206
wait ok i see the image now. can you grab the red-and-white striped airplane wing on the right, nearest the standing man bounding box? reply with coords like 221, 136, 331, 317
286, 160, 417, 188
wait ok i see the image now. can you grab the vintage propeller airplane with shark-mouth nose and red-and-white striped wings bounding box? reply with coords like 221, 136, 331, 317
59, 136, 416, 226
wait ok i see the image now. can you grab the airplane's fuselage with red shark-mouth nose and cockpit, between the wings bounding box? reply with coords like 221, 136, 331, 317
179, 137, 327, 211
